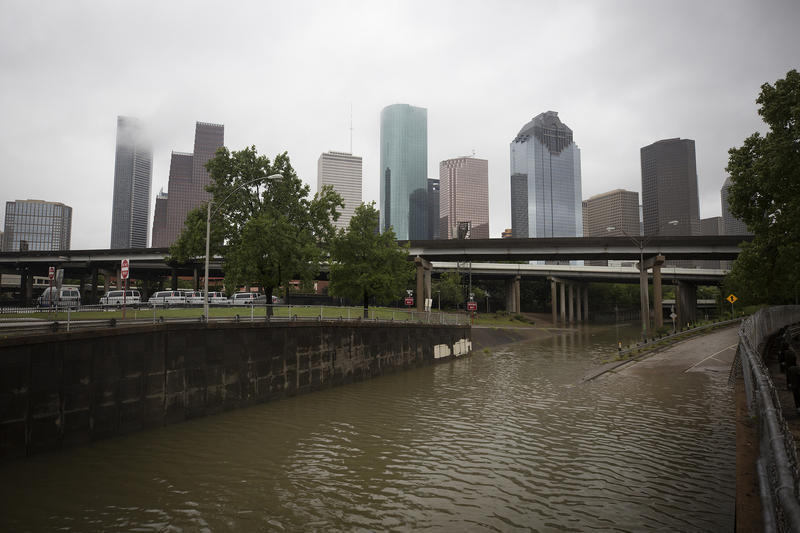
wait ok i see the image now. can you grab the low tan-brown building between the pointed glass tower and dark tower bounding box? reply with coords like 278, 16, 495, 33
583, 189, 639, 237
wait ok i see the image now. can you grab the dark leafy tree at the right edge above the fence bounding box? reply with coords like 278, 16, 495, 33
725, 70, 800, 304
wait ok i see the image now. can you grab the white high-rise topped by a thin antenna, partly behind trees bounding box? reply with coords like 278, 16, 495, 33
317, 152, 361, 228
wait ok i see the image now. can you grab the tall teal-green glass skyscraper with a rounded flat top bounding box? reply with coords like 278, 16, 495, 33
380, 104, 428, 240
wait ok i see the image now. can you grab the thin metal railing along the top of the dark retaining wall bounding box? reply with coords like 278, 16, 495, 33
0, 304, 469, 337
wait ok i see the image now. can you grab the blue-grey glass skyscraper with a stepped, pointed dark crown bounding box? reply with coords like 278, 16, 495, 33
511, 111, 583, 238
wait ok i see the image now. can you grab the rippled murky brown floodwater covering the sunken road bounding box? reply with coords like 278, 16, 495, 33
0, 327, 735, 531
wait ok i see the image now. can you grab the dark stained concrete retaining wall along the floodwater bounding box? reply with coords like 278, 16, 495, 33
0, 323, 471, 460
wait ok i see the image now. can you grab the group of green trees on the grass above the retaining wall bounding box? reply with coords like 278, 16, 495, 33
170, 146, 413, 316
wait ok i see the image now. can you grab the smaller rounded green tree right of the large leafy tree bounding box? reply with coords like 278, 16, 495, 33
328, 202, 414, 318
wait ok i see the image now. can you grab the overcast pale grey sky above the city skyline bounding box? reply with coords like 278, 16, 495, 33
0, 0, 800, 249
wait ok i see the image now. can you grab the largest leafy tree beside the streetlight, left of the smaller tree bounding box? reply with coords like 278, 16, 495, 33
170, 146, 344, 312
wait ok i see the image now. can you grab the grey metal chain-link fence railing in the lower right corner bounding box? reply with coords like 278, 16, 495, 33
736, 306, 800, 532
